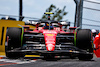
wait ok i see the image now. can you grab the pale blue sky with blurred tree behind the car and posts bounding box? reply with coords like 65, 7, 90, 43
0, 0, 100, 30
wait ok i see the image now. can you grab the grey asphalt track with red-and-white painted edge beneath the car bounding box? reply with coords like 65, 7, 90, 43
0, 57, 100, 67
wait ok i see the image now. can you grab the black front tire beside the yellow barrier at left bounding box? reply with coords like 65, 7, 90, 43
7, 27, 21, 50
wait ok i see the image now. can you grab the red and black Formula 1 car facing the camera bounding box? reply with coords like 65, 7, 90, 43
6, 12, 93, 60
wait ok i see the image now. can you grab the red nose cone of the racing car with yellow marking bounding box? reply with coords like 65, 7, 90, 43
43, 30, 57, 51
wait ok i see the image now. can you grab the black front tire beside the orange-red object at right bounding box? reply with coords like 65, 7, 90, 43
76, 29, 93, 53
